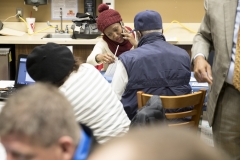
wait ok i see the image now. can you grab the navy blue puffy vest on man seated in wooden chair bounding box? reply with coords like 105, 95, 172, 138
119, 32, 191, 119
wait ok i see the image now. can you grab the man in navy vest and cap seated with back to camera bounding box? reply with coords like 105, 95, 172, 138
112, 10, 191, 119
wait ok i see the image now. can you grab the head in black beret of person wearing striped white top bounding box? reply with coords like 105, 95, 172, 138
26, 43, 80, 87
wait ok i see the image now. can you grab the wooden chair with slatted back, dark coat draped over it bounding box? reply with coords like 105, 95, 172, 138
137, 89, 206, 129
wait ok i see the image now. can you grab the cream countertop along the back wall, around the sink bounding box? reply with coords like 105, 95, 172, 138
0, 22, 200, 45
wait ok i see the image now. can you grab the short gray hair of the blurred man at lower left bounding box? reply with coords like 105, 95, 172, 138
0, 83, 80, 147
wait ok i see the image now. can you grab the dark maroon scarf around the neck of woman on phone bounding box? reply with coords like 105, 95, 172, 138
103, 27, 135, 57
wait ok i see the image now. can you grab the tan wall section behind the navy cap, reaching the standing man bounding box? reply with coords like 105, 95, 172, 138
115, 0, 204, 23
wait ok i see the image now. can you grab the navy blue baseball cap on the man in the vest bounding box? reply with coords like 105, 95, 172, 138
134, 10, 162, 31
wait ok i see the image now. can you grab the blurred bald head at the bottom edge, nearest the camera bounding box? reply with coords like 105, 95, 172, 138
88, 126, 230, 160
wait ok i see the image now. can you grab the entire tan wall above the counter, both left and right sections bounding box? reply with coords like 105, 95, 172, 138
0, 0, 204, 23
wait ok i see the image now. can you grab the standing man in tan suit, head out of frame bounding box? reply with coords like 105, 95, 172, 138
192, 0, 240, 160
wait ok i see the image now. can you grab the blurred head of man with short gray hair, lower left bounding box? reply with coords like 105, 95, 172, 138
0, 83, 93, 160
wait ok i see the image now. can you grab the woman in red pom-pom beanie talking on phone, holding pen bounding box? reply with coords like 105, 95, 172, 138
87, 4, 137, 70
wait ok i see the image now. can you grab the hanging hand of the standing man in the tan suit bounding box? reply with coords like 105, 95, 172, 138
193, 56, 213, 84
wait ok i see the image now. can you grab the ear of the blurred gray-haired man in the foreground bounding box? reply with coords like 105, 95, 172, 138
58, 136, 76, 160
